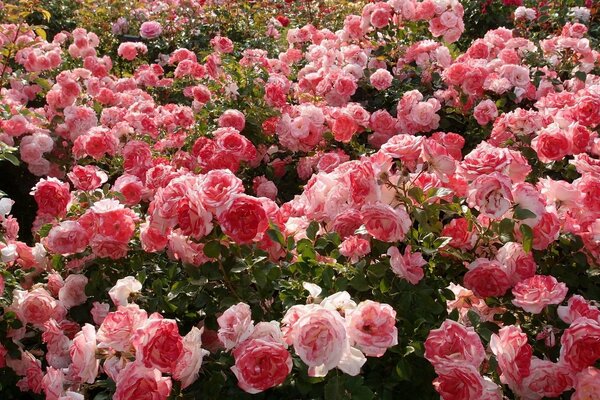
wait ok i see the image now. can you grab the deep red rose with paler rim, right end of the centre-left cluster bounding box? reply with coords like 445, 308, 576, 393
217, 194, 269, 244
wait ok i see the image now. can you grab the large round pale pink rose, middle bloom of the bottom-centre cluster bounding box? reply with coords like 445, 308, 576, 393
293, 307, 348, 373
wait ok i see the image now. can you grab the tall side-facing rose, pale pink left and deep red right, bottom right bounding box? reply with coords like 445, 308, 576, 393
490, 325, 533, 389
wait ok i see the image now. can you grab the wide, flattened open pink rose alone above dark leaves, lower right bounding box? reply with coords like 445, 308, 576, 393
512, 275, 568, 314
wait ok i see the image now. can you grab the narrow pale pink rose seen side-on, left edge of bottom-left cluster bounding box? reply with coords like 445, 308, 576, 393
69, 324, 100, 383
